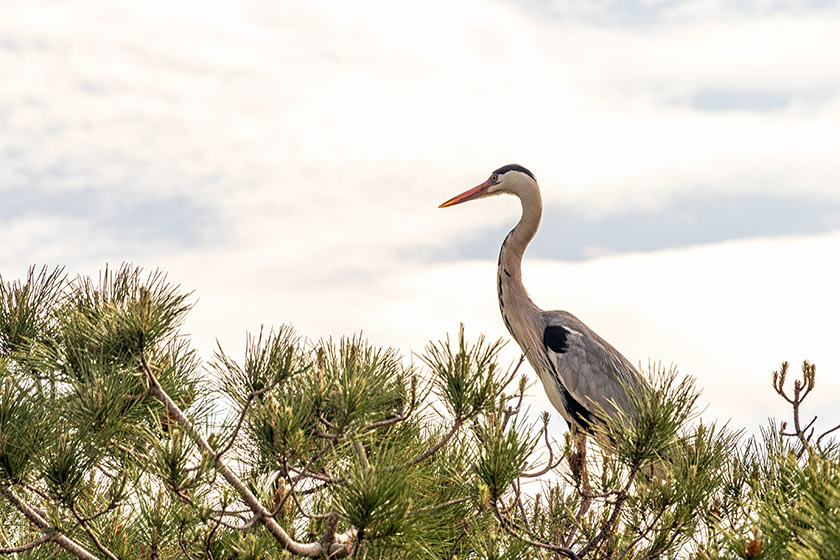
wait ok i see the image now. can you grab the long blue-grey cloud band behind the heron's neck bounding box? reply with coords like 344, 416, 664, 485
450, 189, 840, 261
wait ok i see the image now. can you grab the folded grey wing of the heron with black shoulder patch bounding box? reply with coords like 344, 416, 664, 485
543, 311, 644, 428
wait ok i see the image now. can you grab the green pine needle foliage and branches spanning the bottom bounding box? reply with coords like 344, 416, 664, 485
0, 266, 840, 560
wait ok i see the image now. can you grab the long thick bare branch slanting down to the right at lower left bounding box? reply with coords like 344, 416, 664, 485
140, 351, 353, 558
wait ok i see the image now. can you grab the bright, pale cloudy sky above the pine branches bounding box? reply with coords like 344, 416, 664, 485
0, 0, 840, 433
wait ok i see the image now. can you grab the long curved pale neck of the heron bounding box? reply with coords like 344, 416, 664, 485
498, 189, 542, 337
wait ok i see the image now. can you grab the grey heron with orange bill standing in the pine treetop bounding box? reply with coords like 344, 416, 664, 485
440, 164, 645, 434
